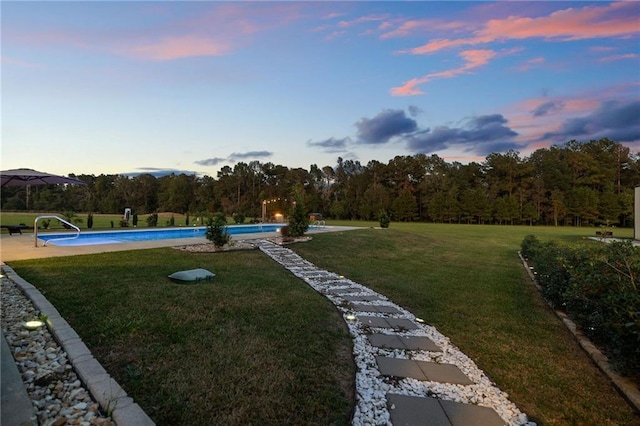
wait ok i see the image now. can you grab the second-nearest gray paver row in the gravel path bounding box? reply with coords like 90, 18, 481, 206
376, 356, 473, 385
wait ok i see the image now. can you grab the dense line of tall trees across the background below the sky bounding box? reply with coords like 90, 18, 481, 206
1, 139, 640, 226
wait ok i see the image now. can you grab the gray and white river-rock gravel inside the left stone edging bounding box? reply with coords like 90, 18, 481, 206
1, 274, 114, 426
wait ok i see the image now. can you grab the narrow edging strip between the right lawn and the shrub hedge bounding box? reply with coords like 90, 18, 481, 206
518, 252, 640, 413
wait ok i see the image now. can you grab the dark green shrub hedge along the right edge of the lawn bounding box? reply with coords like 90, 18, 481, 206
521, 235, 640, 377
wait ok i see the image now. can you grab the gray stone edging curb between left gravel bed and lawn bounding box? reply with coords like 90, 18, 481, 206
2, 264, 155, 426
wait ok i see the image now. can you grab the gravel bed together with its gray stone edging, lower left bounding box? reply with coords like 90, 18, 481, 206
1, 264, 155, 426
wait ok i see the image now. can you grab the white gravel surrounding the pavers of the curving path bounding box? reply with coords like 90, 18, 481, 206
258, 241, 535, 426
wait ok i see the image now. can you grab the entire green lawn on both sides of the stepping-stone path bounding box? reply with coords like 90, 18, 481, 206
10, 222, 640, 425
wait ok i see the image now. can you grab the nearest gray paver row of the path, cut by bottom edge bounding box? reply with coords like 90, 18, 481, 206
387, 393, 505, 426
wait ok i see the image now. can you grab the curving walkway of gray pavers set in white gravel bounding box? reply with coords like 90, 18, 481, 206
258, 240, 527, 426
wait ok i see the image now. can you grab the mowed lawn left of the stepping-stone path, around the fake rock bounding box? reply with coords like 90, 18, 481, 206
10, 248, 355, 425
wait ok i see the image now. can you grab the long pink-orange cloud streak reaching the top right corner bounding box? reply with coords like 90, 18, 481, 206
401, 1, 640, 55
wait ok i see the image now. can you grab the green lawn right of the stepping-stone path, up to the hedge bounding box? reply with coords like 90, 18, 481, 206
291, 223, 640, 425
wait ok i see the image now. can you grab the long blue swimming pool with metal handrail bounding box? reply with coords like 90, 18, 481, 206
38, 223, 285, 246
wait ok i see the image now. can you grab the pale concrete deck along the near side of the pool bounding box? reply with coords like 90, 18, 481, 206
0, 226, 359, 262
